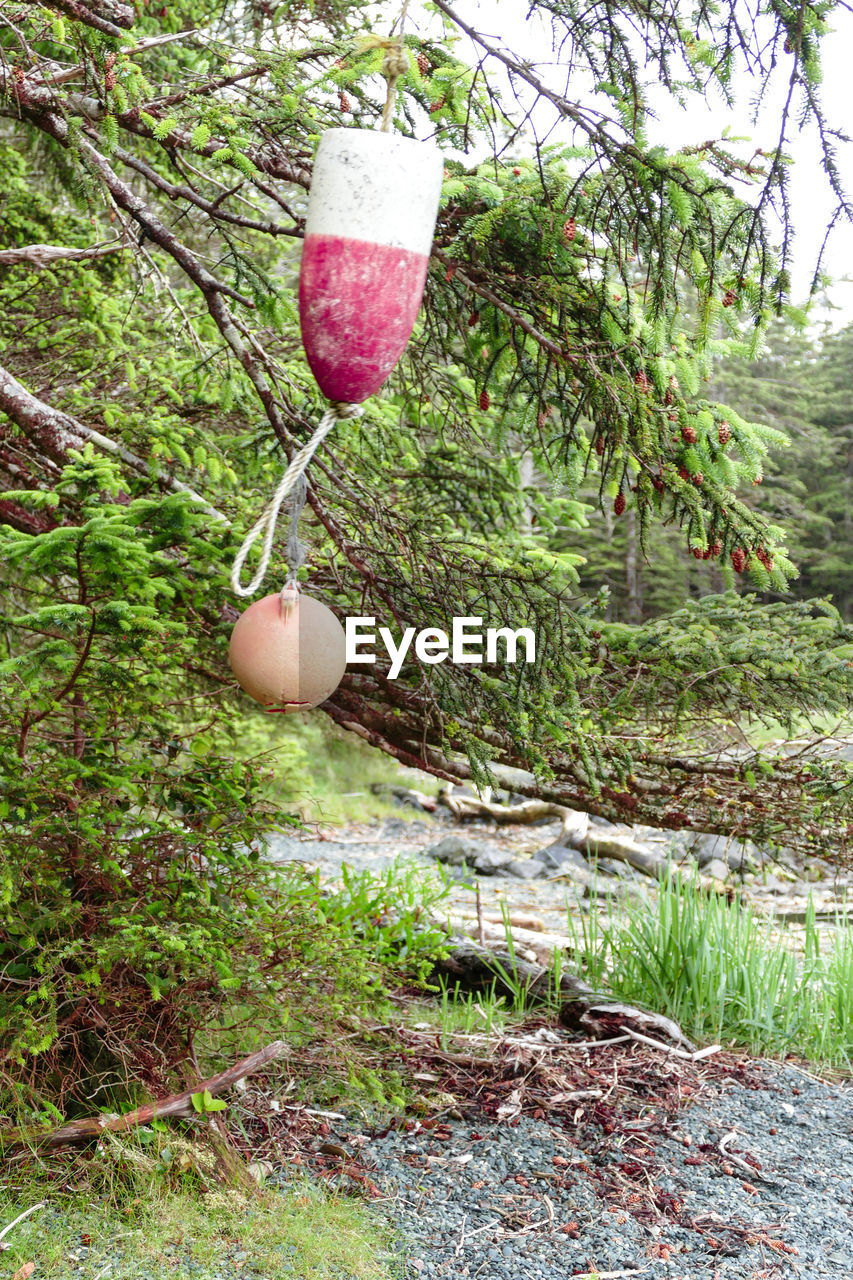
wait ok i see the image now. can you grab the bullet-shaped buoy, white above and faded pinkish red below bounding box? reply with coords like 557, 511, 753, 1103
300, 129, 443, 404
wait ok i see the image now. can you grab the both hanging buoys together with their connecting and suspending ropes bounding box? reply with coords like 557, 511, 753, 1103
229, 41, 443, 712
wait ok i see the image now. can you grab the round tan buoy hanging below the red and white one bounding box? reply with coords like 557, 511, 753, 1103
229, 590, 347, 712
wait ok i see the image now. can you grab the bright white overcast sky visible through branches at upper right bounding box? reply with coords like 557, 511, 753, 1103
409, 0, 853, 324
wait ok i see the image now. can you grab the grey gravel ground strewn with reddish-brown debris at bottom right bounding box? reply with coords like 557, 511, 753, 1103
290, 1059, 853, 1280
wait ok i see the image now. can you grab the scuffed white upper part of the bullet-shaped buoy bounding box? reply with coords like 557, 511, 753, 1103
305, 129, 444, 255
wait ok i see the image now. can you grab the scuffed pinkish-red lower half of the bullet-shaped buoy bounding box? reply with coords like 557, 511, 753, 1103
300, 234, 429, 404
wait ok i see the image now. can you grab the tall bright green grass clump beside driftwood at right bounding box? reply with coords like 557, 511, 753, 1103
560, 877, 853, 1069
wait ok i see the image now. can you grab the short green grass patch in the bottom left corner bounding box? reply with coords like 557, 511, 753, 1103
0, 1148, 392, 1280
